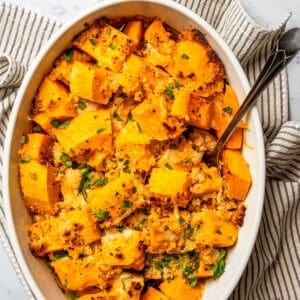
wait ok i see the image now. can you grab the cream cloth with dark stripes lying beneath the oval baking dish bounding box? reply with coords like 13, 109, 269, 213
0, 0, 300, 300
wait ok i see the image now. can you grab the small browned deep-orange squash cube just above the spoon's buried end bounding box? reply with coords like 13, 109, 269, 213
188, 93, 213, 129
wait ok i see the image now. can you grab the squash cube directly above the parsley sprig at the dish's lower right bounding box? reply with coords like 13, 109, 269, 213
191, 210, 238, 248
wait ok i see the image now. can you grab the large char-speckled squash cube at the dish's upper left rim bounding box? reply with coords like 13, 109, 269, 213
73, 21, 132, 73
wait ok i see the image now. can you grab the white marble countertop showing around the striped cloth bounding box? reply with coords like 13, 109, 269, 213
0, 0, 300, 300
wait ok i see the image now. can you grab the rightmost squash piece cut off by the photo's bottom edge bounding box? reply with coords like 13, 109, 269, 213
159, 277, 204, 300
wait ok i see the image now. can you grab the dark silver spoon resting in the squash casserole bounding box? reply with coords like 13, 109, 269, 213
203, 28, 300, 170
